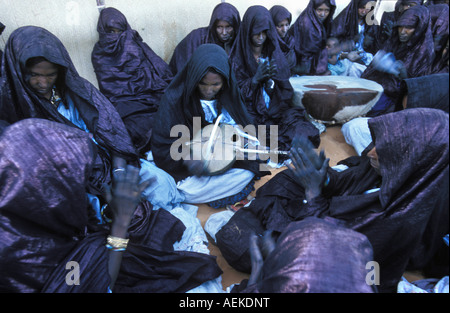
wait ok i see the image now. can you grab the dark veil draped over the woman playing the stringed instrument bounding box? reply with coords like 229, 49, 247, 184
152, 44, 252, 180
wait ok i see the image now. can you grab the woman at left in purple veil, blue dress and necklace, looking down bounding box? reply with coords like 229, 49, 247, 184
0, 26, 138, 196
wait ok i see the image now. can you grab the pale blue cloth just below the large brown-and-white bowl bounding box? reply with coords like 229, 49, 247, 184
341, 117, 372, 156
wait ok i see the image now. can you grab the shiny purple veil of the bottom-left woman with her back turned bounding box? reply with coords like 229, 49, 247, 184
0, 119, 94, 292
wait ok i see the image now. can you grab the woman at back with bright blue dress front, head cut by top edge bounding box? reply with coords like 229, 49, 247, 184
330, 0, 374, 66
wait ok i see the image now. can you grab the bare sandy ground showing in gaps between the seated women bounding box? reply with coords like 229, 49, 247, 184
197, 125, 424, 290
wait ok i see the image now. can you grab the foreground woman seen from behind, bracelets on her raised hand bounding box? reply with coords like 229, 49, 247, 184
0, 118, 221, 293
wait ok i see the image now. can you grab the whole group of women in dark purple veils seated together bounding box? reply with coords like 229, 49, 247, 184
0, 0, 449, 292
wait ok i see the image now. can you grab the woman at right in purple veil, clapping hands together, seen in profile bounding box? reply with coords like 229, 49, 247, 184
215, 108, 449, 292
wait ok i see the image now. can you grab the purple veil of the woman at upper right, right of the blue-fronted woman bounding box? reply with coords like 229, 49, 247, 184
361, 5, 434, 99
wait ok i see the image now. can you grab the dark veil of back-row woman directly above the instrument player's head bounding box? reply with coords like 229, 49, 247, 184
169, 2, 241, 74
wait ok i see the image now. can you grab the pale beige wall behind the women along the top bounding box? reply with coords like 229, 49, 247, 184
0, 0, 395, 86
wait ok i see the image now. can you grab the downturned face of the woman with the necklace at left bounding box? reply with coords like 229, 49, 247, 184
28, 61, 58, 99
